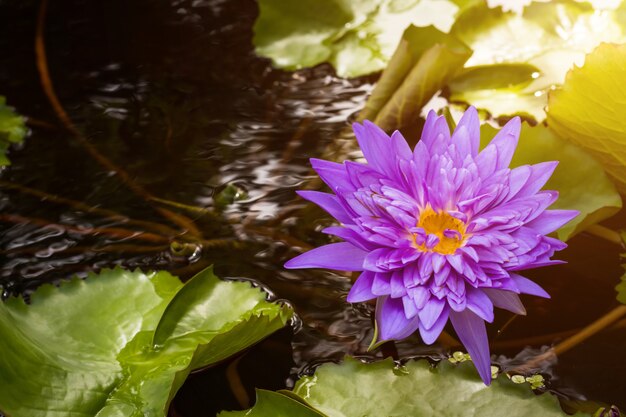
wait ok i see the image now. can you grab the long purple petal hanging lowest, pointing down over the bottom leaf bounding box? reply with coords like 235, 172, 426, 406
450, 310, 491, 385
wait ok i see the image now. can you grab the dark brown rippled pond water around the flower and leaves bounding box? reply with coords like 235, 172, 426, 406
0, 0, 626, 416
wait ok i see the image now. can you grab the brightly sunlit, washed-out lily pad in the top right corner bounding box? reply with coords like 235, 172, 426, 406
450, 0, 626, 121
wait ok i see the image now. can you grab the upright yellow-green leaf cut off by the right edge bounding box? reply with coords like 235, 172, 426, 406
548, 44, 626, 192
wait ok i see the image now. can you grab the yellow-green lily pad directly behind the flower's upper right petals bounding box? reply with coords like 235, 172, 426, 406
480, 123, 622, 240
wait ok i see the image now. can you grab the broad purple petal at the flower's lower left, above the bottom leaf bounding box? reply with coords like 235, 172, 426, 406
376, 297, 419, 340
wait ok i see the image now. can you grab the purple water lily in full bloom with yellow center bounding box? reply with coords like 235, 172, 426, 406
285, 107, 578, 384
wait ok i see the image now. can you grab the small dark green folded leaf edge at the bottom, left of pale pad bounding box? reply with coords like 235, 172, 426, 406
218, 389, 324, 417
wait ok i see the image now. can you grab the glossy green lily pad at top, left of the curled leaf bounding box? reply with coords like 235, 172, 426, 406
254, 0, 458, 77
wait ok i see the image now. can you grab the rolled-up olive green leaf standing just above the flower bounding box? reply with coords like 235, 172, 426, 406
359, 26, 471, 131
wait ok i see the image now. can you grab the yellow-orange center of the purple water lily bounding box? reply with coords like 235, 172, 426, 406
416, 206, 467, 255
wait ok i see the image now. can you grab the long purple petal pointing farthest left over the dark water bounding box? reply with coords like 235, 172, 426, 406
285, 242, 367, 271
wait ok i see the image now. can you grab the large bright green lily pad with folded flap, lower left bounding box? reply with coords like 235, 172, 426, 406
0, 268, 291, 417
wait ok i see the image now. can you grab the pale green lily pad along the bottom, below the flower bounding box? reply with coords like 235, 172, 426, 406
220, 358, 584, 417
